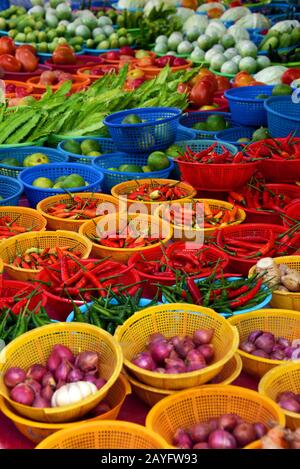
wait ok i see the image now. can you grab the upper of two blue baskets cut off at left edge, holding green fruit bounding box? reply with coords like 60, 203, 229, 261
0, 146, 68, 178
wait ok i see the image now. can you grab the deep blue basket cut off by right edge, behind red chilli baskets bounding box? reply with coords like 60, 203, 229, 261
264, 96, 300, 137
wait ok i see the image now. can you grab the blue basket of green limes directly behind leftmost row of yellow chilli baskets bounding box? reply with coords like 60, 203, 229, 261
18, 163, 104, 207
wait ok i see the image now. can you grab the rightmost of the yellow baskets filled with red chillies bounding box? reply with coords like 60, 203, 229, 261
155, 199, 246, 241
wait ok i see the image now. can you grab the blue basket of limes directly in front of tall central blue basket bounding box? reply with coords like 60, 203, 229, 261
92, 152, 174, 193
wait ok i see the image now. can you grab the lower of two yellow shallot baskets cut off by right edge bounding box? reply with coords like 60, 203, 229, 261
258, 361, 300, 430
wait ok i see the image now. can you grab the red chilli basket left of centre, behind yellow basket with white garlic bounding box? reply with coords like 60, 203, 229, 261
37, 259, 141, 321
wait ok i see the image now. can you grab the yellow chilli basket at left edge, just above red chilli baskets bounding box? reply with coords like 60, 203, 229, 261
0, 230, 92, 282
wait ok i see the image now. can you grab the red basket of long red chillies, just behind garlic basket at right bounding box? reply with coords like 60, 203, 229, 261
214, 223, 286, 276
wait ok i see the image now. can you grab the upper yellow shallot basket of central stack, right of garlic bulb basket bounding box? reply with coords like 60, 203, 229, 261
115, 303, 239, 390
